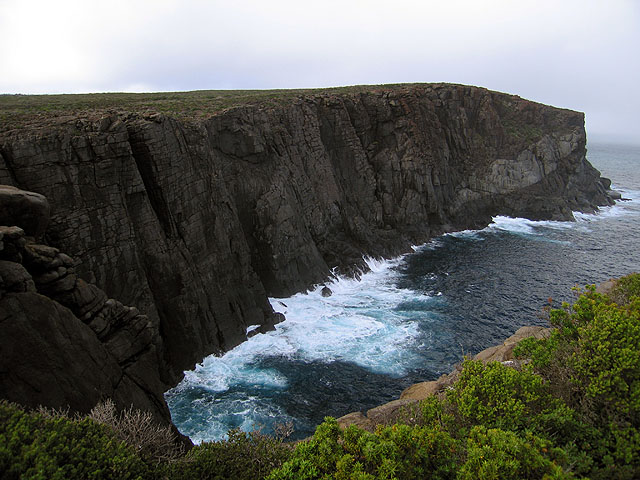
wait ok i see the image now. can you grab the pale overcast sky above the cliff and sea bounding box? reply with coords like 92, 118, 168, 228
0, 0, 640, 143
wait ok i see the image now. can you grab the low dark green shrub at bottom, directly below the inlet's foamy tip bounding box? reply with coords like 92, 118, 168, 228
168, 429, 292, 480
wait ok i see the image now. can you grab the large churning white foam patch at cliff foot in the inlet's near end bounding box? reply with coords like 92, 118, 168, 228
167, 258, 429, 443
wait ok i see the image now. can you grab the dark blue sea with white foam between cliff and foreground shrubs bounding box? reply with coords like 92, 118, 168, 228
166, 144, 640, 441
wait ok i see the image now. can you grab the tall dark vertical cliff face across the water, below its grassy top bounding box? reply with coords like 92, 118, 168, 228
0, 85, 611, 396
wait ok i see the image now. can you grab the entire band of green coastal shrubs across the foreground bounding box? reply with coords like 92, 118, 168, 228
0, 274, 640, 480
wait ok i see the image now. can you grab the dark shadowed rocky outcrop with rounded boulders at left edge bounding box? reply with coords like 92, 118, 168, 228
0, 195, 171, 423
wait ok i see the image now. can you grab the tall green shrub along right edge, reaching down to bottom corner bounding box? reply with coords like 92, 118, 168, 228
514, 274, 640, 479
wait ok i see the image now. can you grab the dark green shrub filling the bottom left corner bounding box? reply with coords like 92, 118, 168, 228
0, 401, 153, 480
